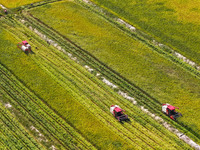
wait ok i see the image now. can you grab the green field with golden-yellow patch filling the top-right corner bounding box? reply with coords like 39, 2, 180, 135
92, 0, 200, 64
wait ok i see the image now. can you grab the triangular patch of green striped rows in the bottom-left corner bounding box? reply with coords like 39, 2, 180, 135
0, 101, 42, 149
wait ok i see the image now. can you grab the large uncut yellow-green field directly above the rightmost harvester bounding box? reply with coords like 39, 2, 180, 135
28, 1, 200, 138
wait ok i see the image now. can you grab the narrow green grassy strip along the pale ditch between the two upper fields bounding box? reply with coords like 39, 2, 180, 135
77, 0, 200, 70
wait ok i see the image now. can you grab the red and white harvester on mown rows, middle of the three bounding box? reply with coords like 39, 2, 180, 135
110, 105, 130, 122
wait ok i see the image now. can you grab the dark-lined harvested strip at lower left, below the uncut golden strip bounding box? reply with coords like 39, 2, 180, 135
2, 63, 97, 149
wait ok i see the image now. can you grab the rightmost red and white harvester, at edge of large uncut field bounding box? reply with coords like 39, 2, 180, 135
162, 104, 182, 120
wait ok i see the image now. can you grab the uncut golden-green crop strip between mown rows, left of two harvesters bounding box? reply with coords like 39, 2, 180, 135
1, 22, 138, 149
